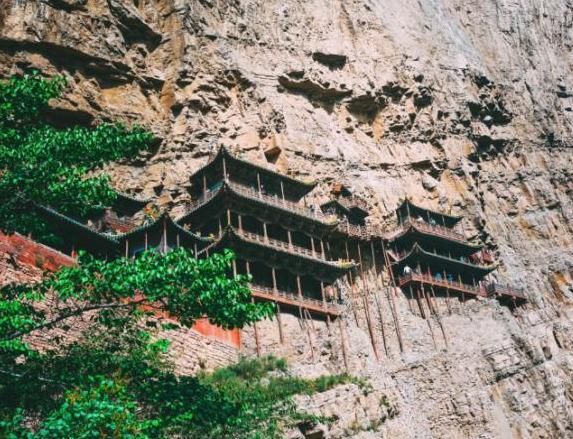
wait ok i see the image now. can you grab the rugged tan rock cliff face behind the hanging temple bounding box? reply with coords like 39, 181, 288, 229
0, 0, 573, 438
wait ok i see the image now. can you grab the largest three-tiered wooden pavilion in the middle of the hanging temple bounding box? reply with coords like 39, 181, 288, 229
177, 148, 354, 318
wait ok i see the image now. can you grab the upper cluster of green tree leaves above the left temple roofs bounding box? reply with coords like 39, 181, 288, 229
0, 74, 152, 242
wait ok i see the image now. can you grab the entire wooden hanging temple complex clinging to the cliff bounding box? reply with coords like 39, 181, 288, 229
33, 147, 527, 336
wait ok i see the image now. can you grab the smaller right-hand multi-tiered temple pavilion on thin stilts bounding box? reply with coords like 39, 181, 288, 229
386, 199, 525, 303
